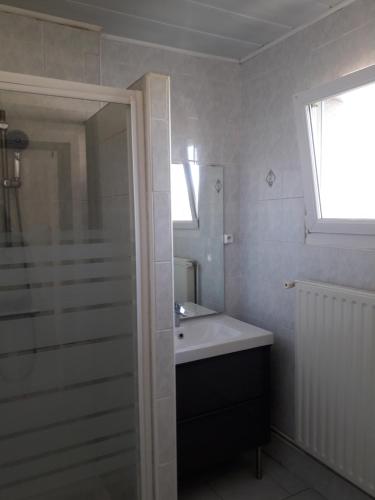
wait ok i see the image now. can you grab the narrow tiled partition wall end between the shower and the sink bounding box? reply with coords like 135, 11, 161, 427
132, 73, 177, 500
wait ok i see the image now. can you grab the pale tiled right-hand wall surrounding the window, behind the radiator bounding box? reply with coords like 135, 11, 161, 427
240, 0, 375, 435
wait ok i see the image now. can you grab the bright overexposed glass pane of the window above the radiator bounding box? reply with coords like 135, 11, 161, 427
309, 84, 375, 219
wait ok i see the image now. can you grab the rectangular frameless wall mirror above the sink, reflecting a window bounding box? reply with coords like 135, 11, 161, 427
171, 161, 224, 318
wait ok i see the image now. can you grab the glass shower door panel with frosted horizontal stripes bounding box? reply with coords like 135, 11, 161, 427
0, 91, 139, 500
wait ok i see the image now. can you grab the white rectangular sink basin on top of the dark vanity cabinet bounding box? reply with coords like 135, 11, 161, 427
175, 314, 273, 364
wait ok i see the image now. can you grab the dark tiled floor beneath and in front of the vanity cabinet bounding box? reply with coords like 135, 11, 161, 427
178, 456, 324, 500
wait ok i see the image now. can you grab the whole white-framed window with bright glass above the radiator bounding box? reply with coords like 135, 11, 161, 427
295, 67, 375, 248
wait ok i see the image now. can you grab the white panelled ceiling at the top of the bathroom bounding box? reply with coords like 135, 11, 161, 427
2, 0, 356, 60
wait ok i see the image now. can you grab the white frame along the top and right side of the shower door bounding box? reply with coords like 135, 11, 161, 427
0, 71, 154, 500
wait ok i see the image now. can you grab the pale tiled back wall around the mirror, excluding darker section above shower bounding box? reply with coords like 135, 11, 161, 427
101, 39, 241, 315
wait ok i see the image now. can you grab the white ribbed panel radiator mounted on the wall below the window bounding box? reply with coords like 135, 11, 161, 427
296, 282, 375, 495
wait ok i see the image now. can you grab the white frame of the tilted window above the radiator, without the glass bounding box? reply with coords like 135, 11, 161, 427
294, 66, 375, 248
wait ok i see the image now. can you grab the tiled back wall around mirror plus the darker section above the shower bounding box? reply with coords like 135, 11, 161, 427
0, 8, 241, 320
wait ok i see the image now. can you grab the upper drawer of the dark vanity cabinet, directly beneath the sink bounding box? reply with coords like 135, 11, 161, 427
176, 346, 270, 420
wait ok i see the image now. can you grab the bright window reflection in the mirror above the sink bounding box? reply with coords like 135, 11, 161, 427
171, 162, 199, 229
